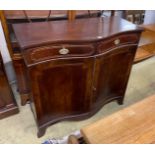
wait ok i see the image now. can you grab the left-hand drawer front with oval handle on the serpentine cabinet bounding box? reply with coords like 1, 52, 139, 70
24, 45, 95, 62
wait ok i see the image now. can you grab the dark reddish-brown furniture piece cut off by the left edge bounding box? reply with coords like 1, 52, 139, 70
0, 55, 19, 119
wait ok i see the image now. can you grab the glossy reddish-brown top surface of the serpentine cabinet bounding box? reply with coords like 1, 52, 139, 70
13, 17, 142, 49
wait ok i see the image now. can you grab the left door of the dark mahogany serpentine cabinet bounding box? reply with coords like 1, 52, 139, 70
29, 58, 94, 125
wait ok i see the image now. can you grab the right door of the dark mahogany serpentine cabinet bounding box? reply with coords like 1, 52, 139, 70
93, 45, 137, 106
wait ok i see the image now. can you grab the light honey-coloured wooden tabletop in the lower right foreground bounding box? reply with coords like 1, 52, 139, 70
81, 95, 155, 144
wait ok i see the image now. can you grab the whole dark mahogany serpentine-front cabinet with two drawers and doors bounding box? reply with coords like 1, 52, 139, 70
13, 17, 143, 137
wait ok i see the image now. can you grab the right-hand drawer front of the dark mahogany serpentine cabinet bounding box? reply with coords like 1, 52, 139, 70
97, 34, 139, 53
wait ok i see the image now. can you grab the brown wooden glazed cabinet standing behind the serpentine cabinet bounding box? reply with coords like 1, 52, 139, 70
0, 10, 102, 105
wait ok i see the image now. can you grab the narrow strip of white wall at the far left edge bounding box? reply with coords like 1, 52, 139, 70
0, 21, 11, 63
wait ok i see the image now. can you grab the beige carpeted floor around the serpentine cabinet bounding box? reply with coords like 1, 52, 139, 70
0, 57, 155, 143
